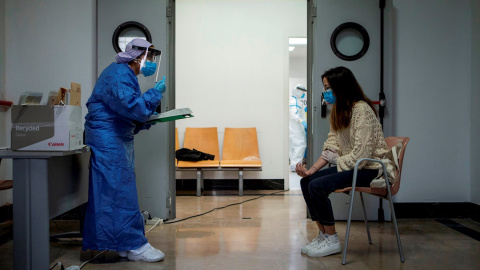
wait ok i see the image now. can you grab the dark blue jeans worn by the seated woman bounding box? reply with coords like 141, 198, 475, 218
300, 167, 378, 226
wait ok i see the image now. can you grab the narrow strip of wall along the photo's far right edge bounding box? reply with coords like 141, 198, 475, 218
470, 0, 480, 204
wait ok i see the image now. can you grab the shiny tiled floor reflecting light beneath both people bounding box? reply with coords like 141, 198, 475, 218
0, 190, 480, 270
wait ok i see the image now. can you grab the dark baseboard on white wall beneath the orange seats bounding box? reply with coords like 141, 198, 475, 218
176, 179, 285, 190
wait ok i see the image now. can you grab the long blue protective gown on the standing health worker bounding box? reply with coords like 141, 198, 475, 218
83, 63, 162, 251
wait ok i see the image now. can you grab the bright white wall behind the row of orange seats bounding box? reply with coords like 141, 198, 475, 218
176, 0, 307, 179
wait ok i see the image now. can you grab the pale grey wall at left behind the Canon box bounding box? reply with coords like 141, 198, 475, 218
0, 0, 96, 204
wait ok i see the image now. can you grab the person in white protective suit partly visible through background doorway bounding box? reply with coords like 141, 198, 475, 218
289, 84, 307, 171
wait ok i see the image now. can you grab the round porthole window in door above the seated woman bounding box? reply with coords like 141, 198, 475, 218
330, 22, 370, 61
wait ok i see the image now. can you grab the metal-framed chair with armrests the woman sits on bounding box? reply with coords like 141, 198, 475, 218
335, 137, 410, 265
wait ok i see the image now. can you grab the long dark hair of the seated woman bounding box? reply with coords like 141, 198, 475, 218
322, 67, 377, 131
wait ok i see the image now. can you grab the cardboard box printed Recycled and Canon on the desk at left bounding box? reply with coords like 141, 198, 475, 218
11, 105, 83, 151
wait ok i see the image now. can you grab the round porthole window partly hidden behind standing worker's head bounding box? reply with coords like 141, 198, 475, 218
112, 21, 152, 53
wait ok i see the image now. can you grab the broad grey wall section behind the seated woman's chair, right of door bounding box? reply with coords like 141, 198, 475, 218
392, 0, 470, 202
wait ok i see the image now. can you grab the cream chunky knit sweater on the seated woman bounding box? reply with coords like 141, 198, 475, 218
323, 101, 395, 175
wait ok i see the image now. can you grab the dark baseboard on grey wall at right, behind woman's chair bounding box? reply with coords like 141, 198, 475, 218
394, 202, 480, 222
